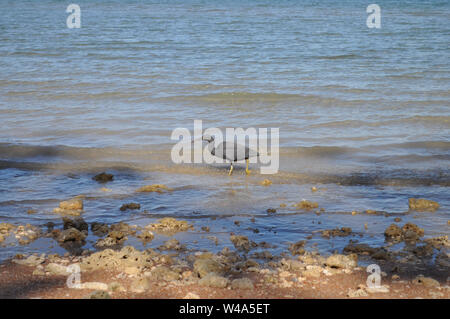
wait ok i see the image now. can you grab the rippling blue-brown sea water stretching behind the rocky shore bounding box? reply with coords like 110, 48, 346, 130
0, 0, 450, 258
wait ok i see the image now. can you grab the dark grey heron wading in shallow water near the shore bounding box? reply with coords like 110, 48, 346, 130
202, 135, 259, 175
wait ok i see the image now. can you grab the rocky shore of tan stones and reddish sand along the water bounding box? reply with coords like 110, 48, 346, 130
0, 185, 450, 299
